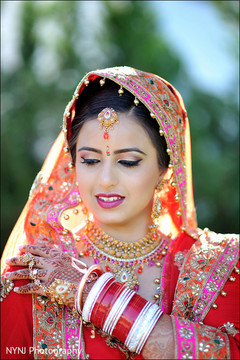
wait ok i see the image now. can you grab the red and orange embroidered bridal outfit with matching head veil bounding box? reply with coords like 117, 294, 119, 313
1, 67, 239, 359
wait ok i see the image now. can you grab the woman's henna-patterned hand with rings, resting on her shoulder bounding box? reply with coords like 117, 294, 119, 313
4, 245, 86, 307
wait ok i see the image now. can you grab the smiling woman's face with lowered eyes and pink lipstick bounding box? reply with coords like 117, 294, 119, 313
76, 113, 161, 229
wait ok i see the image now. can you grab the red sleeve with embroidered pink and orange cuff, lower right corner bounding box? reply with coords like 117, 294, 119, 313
171, 261, 240, 359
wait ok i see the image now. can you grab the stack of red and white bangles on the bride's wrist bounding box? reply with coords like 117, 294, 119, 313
76, 265, 163, 354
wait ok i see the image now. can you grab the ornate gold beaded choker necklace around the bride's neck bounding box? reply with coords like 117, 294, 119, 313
79, 221, 168, 291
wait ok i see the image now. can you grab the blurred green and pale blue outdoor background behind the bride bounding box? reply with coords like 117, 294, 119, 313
1, 1, 239, 253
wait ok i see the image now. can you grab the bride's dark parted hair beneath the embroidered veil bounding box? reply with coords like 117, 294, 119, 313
69, 79, 170, 170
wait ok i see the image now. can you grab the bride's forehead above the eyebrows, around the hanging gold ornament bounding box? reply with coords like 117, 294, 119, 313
77, 113, 153, 147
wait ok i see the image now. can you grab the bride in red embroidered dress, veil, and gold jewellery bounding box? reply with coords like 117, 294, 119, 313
1, 67, 239, 359
